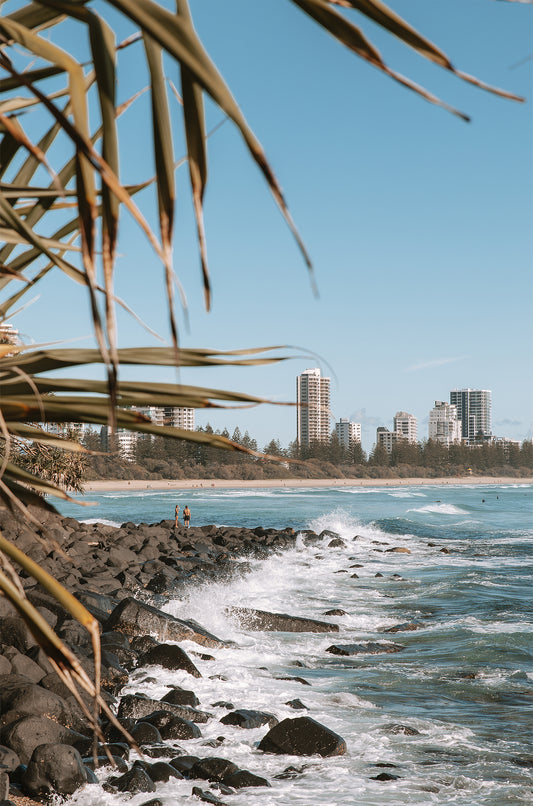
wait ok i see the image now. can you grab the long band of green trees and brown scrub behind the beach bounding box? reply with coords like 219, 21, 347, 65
83, 426, 533, 481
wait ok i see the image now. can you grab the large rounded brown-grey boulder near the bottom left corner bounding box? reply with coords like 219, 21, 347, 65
22, 744, 88, 797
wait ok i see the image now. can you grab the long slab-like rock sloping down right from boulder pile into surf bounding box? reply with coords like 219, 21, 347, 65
105, 598, 224, 647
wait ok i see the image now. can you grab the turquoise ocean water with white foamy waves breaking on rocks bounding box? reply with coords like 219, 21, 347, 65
55, 483, 533, 806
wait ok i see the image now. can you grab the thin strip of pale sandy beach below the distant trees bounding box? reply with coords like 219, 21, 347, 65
85, 476, 533, 493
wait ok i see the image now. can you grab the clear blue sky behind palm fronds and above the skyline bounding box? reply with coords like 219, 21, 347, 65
9, 0, 533, 449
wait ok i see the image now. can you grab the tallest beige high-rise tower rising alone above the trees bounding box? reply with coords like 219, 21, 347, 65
296, 369, 331, 448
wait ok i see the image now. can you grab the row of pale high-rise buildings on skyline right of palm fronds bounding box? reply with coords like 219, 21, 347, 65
296, 368, 520, 453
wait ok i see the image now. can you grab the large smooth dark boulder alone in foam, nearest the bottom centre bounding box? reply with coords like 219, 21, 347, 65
259, 716, 346, 757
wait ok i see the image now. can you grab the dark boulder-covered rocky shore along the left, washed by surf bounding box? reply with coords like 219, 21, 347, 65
0, 508, 346, 806
